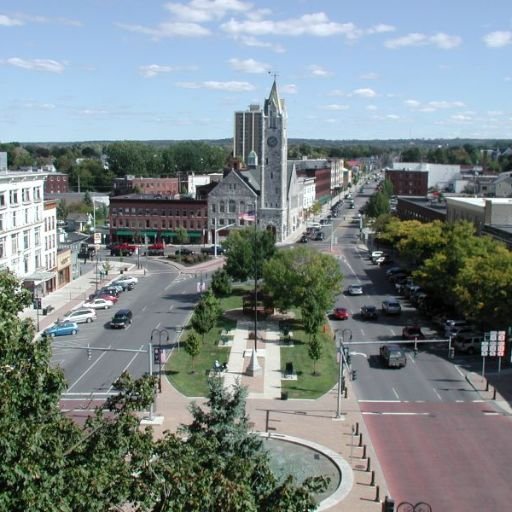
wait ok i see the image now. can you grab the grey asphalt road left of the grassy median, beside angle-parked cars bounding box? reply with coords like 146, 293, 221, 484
53, 261, 207, 398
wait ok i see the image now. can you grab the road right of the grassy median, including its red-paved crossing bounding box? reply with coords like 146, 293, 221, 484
324, 189, 512, 512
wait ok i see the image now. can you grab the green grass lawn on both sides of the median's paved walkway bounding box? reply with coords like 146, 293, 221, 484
165, 286, 338, 398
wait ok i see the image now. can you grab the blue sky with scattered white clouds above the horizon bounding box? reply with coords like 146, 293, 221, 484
0, 0, 512, 142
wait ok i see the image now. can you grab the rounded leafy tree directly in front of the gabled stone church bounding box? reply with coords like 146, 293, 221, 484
223, 227, 276, 281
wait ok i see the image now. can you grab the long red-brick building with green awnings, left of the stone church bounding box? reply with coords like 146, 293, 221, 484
109, 194, 208, 243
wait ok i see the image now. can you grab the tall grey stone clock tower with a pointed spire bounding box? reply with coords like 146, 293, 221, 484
260, 79, 288, 239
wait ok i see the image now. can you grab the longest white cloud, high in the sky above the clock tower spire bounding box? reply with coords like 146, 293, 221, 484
221, 12, 362, 39
